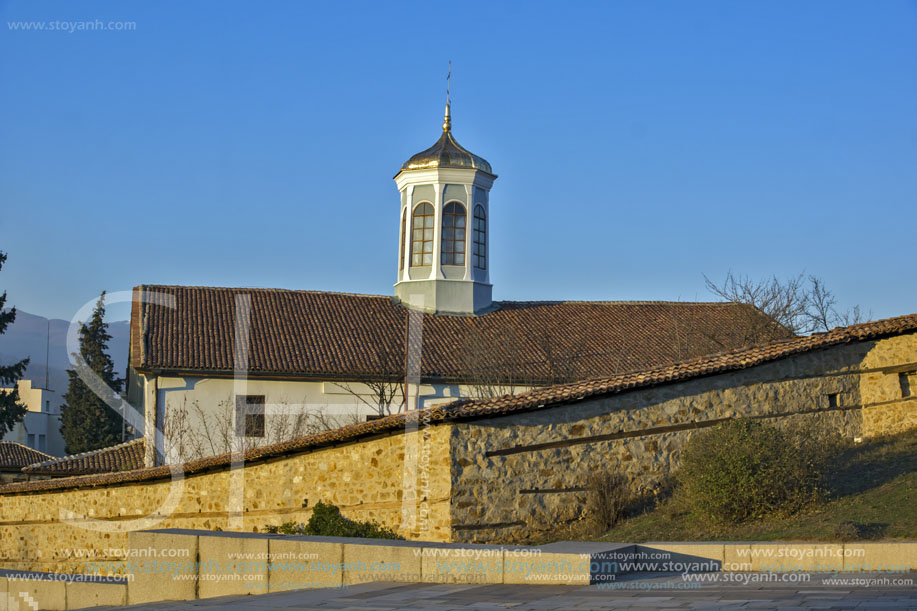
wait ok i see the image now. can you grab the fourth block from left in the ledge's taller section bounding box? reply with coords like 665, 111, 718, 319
343, 543, 422, 586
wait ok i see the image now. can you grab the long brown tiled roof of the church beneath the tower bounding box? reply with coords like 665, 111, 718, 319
130, 286, 789, 383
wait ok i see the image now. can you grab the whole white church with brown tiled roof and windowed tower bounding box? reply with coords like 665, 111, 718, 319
128, 101, 790, 466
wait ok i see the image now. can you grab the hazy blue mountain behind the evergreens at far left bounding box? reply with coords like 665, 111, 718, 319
0, 310, 130, 392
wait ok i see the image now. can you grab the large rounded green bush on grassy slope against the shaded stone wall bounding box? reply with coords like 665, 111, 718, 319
676, 420, 830, 524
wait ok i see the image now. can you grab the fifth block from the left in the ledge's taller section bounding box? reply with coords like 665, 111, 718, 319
421, 546, 505, 585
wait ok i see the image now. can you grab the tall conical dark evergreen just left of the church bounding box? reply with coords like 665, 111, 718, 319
61, 291, 123, 454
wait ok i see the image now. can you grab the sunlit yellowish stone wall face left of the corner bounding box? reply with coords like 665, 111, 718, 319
0, 426, 450, 574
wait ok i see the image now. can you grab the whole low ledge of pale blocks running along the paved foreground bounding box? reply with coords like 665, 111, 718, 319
12, 529, 900, 611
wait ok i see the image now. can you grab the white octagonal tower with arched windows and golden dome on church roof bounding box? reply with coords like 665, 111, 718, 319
395, 100, 497, 315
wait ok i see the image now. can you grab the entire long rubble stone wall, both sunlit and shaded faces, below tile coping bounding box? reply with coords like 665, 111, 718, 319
0, 333, 917, 573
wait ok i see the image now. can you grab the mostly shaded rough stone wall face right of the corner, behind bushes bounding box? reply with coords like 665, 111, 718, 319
451, 334, 917, 542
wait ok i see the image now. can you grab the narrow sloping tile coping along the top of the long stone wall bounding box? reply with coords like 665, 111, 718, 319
0, 314, 917, 493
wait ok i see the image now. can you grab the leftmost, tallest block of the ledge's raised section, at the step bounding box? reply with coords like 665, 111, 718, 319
127, 530, 198, 605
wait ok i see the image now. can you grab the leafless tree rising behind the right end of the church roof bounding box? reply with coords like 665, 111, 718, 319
704, 271, 864, 344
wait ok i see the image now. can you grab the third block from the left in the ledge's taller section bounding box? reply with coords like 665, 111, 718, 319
268, 537, 344, 592
